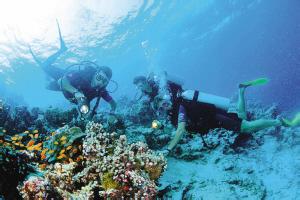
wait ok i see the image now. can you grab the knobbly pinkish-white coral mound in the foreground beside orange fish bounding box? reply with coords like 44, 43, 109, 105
20, 122, 166, 199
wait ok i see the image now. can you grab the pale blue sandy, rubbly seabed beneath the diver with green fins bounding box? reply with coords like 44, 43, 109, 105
158, 103, 300, 199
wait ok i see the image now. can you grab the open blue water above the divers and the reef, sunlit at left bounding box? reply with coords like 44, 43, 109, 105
0, 0, 300, 115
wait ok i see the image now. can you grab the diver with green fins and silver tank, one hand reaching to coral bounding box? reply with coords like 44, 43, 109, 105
157, 78, 300, 156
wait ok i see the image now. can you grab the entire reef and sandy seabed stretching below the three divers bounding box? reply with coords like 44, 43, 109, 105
0, 99, 300, 199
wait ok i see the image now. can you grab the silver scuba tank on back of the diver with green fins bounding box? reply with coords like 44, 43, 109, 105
181, 90, 230, 111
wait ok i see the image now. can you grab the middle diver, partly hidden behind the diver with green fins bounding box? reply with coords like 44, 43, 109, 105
133, 73, 159, 102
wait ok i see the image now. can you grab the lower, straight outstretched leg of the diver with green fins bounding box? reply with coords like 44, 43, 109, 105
241, 119, 282, 133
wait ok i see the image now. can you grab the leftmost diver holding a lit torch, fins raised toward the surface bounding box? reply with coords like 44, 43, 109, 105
29, 22, 117, 117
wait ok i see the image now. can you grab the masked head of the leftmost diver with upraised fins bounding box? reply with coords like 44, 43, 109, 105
91, 66, 112, 88
